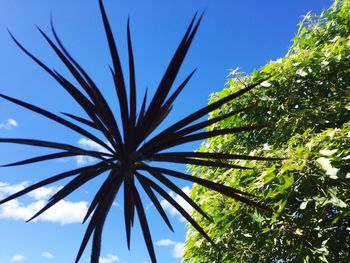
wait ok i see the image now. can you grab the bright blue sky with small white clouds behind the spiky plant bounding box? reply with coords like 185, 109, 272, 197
0, 0, 331, 263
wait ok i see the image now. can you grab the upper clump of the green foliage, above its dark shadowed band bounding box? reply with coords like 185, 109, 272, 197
210, 2, 350, 151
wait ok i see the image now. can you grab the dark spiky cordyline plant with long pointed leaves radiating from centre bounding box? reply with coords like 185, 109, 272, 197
0, 0, 273, 263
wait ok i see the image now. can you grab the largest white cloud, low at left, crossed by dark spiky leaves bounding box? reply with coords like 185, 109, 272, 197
0, 182, 88, 225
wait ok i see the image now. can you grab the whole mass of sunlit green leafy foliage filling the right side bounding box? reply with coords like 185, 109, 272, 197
184, 0, 350, 263
